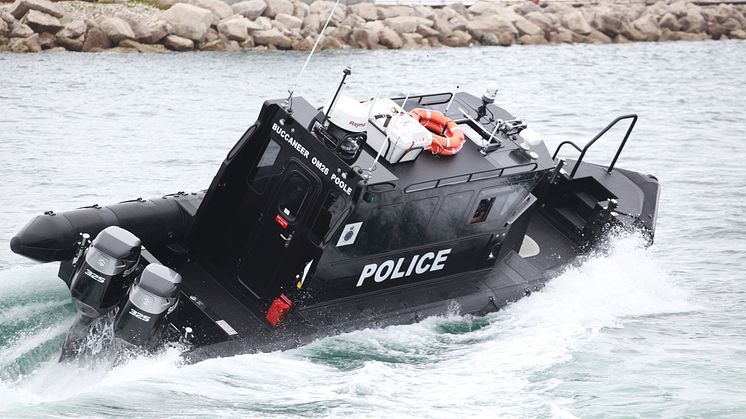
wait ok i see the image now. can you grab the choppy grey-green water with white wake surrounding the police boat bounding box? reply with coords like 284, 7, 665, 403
0, 41, 746, 418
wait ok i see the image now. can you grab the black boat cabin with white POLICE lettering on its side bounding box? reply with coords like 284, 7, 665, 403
188, 93, 554, 310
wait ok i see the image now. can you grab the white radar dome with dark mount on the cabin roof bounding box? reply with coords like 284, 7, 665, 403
323, 96, 369, 163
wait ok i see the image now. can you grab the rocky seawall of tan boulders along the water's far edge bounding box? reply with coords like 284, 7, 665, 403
0, 0, 746, 52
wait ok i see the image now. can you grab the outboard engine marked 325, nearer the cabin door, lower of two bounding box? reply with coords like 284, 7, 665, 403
114, 263, 181, 347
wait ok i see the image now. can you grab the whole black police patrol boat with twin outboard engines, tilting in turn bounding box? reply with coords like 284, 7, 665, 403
11, 72, 659, 362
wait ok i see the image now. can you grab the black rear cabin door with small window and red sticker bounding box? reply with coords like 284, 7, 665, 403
238, 161, 321, 298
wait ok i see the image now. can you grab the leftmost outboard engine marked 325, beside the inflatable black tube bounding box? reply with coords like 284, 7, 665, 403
70, 226, 142, 319
